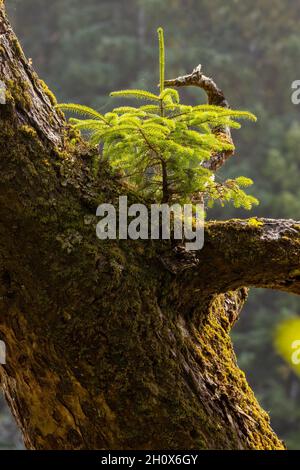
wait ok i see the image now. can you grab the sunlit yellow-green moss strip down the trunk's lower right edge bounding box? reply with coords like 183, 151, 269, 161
186, 291, 283, 450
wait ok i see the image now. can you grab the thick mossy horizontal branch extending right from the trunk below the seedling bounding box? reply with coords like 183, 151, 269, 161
165, 219, 300, 312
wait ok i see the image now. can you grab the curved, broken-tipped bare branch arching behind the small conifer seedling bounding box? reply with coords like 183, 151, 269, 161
165, 65, 233, 171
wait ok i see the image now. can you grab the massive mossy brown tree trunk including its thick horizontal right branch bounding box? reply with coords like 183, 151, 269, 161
0, 0, 300, 450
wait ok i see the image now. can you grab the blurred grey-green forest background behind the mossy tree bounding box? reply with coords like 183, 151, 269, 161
0, 0, 300, 449
